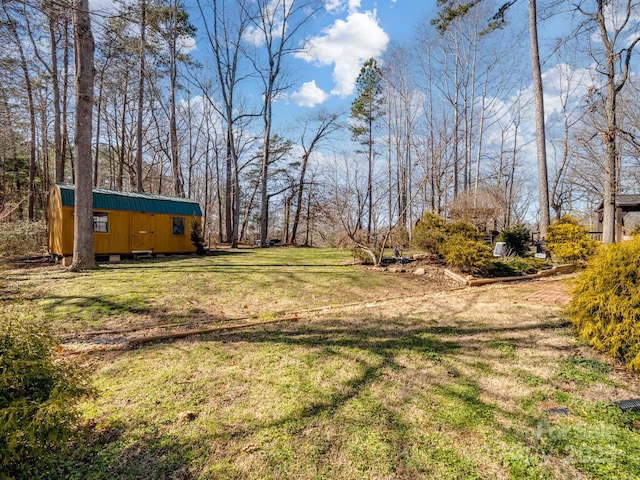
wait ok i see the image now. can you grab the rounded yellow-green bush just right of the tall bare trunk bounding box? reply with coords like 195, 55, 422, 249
546, 215, 598, 264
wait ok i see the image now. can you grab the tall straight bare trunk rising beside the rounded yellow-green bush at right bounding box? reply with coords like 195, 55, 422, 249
529, 0, 550, 238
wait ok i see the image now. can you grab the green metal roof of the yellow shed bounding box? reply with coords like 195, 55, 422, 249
56, 183, 202, 217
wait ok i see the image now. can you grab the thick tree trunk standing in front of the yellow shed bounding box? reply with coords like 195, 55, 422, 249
71, 0, 95, 271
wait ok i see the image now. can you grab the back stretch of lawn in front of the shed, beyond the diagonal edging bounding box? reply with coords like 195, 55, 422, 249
18, 248, 410, 331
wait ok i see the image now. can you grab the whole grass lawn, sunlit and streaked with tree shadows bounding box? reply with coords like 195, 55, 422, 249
0, 248, 640, 479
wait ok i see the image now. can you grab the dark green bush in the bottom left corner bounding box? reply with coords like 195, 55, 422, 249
0, 307, 94, 478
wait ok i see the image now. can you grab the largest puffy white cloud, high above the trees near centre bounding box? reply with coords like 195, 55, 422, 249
297, 10, 389, 97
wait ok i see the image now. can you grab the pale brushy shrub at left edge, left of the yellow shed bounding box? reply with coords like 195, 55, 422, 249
0, 220, 47, 257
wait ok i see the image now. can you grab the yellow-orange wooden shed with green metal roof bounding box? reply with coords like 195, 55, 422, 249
47, 183, 202, 257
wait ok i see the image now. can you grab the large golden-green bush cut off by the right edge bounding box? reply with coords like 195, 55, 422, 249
567, 238, 640, 372
